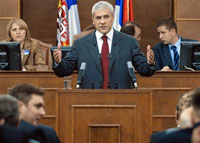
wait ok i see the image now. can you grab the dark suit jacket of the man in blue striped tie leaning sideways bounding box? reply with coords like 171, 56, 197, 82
153, 38, 195, 70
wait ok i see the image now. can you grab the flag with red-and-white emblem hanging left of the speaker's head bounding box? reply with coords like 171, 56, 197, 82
57, 0, 81, 46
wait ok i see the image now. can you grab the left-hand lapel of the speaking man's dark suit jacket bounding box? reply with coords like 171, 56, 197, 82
87, 32, 101, 72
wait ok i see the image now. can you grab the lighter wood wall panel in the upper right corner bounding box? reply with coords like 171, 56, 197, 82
174, 0, 200, 40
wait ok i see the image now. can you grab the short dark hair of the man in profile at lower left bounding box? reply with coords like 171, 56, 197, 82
9, 83, 44, 104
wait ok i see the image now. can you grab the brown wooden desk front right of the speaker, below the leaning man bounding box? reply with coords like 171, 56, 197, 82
70, 71, 200, 89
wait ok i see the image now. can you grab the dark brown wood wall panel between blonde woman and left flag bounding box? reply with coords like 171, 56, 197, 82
22, 0, 58, 45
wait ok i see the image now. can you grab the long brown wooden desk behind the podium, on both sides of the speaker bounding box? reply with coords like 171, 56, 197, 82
0, 71, 200, 94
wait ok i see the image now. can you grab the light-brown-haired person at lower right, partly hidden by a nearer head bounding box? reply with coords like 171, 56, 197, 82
151, 91, 193, 143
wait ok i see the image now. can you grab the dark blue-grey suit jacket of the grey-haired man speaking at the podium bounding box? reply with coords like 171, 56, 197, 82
54, 30, 155, 89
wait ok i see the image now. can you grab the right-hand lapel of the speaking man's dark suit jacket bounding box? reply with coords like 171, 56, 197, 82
109, 30, 122, 71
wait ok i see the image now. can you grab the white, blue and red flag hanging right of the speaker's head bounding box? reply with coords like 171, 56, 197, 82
113, 0, 134, 31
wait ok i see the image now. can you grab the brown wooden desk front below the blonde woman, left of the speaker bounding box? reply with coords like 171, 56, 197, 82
0, 71, 64, 94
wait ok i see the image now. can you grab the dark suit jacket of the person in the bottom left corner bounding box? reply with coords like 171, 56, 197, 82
0, 124, 28, 143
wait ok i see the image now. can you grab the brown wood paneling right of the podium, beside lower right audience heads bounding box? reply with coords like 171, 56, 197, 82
151, 88, 191, 132
